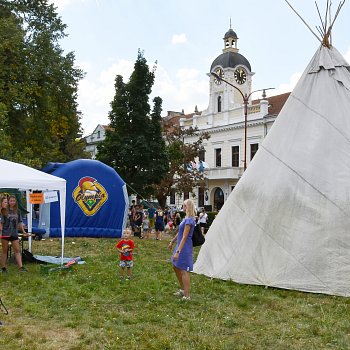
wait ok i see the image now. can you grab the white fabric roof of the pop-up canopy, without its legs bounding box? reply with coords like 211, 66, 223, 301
0, 159, 66, 191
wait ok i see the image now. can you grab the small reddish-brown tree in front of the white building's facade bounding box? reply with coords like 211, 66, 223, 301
153, 126, 210, 207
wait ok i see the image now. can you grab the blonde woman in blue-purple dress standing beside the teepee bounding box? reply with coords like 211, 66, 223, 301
168, 199, 196, 300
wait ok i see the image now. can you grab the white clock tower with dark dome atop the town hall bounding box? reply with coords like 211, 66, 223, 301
207, 28, 254, 114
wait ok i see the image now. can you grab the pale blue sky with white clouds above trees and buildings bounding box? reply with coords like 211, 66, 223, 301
49, 0, 350, 136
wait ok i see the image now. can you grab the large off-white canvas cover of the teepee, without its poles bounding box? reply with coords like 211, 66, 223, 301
194, 4, 350, 296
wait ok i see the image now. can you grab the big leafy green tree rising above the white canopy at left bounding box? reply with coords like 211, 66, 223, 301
0, 0, 86, 168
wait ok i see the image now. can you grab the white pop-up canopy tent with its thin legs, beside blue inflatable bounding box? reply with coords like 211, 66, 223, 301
0, 159, 66, 261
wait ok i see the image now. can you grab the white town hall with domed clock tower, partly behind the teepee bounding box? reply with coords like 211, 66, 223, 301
168, 29, 289, 211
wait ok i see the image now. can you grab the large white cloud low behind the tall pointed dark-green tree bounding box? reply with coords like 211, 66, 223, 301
78, 60, 209, 135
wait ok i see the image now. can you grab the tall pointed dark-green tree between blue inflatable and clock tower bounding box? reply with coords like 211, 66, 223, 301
97, 50, 168, 197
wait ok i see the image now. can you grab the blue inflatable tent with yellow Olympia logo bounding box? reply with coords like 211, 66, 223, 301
40, 159, 129, 237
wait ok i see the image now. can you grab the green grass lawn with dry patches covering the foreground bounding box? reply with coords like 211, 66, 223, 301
0, 238, 350, 350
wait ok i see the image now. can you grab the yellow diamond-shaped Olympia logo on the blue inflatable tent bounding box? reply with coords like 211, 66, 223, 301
72, 176, 108, 216
